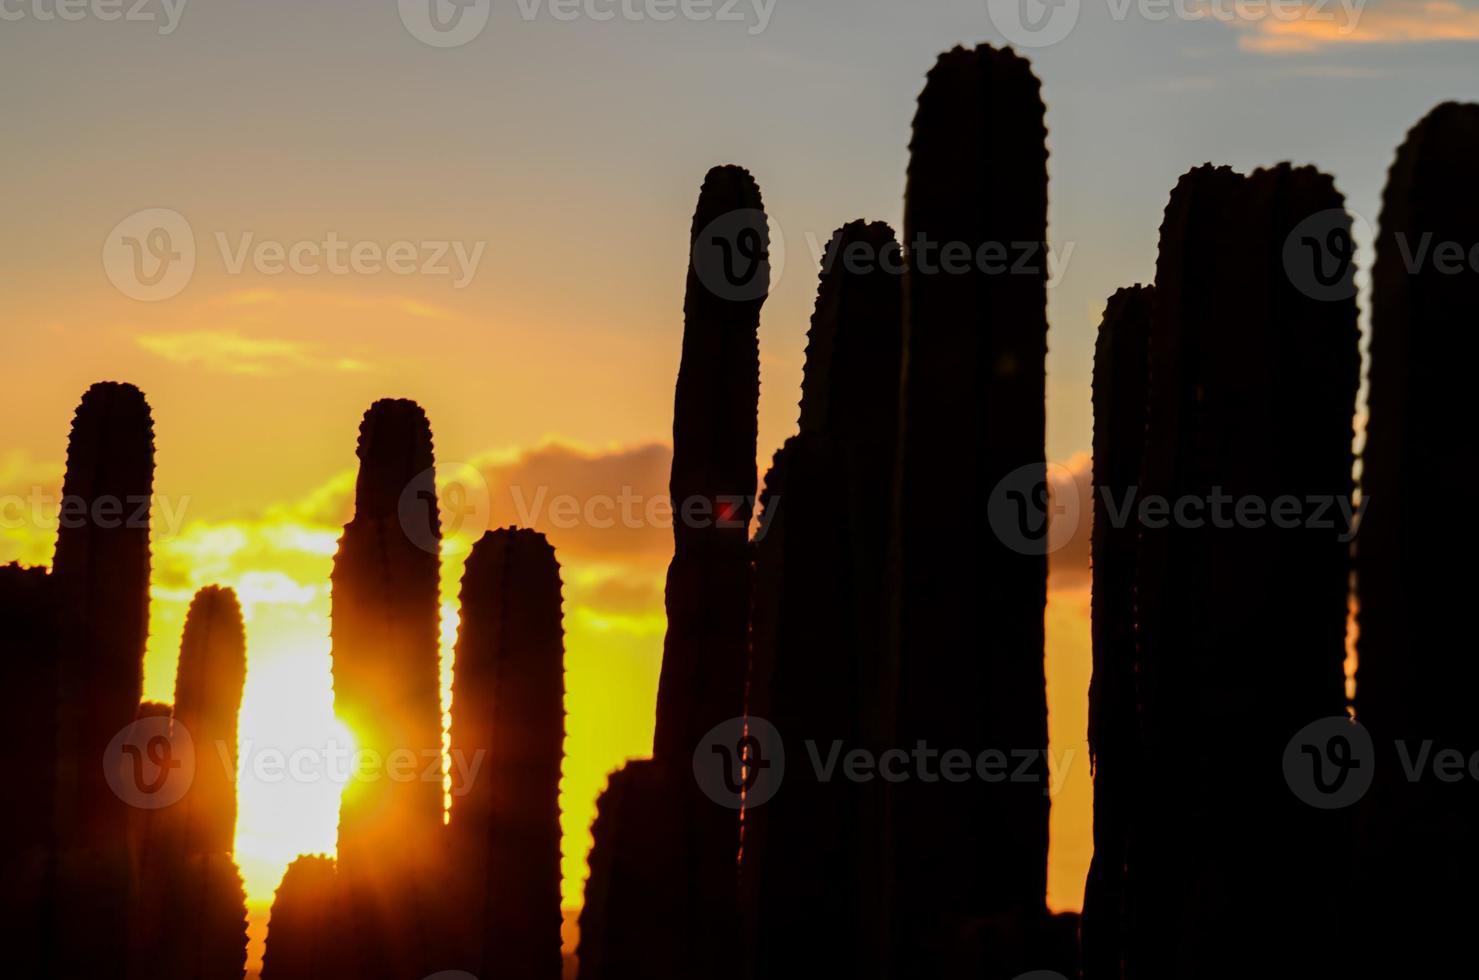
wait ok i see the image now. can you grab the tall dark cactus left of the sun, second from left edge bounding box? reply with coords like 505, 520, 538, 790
43, 383, 154, 980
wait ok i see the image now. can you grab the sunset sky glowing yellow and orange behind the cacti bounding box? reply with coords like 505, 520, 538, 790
0, 0, 1479, 963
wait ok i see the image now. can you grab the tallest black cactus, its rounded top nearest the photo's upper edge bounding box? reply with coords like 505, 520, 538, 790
895, 46, 1049, 977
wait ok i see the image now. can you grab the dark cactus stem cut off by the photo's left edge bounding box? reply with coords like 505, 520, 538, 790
0, 565, 58, 977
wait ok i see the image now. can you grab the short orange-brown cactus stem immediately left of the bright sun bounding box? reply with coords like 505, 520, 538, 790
175, 585, 247, 854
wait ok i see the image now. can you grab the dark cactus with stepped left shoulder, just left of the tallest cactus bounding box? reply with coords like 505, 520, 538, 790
744, 222, 902, 977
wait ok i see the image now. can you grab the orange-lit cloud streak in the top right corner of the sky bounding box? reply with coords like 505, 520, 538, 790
1233, 0, 1479, 55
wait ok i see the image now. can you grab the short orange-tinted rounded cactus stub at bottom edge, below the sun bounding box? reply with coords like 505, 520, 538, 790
262, 854, 352, 980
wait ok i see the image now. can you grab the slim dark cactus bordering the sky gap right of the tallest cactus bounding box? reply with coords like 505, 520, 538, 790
1083, 285, 1155, 980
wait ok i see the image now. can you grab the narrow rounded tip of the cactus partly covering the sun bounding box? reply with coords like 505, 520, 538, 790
355, 398, 435, 519
